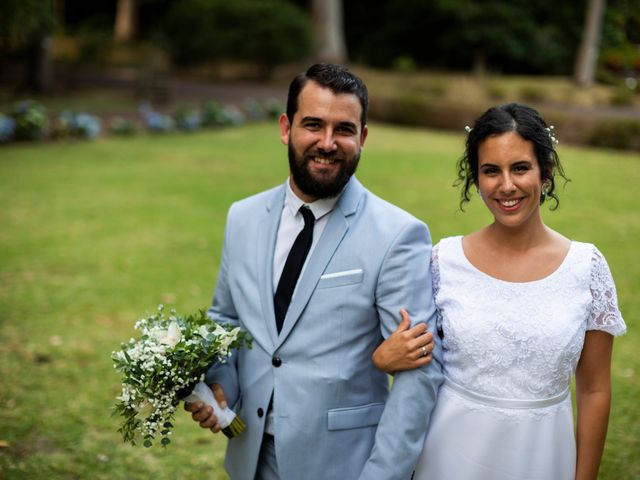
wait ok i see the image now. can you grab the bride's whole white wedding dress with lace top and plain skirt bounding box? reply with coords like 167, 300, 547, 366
414, 237, 626, 480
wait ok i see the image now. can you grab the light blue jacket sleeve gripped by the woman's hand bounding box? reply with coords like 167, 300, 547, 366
360, 220, 443, 480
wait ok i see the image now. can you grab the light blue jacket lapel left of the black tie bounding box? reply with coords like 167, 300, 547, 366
255, 186, 285, 344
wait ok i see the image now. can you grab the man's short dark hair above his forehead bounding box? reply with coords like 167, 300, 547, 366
287, 63, 369, 127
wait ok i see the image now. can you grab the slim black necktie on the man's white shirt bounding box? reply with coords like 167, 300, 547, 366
273, 206, 315, 333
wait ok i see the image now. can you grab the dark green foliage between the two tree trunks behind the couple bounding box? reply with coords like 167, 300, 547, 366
345, 0, 582, 74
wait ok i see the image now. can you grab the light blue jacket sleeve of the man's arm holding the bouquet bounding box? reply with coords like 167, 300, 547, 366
205, 205, 240, 408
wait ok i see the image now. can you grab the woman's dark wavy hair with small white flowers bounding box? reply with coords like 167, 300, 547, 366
455, 103, 569, 210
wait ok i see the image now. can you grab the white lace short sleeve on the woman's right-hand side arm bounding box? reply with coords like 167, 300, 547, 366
587, 247, 627, 335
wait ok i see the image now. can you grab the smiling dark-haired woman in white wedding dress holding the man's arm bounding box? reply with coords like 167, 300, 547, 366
374, 104, 626, 480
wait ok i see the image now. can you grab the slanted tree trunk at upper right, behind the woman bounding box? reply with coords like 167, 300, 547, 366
574, 0, 606, 87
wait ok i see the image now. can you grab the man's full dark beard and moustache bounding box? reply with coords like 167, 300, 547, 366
288, 142, 360, 198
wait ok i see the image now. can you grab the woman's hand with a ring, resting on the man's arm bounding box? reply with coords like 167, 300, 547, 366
372, 308, 434, 373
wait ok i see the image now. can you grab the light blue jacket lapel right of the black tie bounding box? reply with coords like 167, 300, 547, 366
271, 177, 364, 347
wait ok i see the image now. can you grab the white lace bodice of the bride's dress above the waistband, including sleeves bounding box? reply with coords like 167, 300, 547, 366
432, 237, 626, 408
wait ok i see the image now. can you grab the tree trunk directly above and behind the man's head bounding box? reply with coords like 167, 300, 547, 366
311, 0, 347, 64
